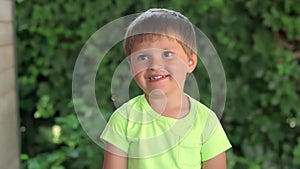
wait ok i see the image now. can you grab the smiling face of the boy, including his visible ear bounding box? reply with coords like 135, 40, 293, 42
129, 35, 197, 95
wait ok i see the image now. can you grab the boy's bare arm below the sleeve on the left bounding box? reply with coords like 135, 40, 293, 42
103, 143, 127, 169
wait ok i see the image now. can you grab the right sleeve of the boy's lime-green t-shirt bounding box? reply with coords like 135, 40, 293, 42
201, 112, 231, 161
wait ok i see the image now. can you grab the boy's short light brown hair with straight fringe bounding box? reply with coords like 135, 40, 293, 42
123, 8, 197, 56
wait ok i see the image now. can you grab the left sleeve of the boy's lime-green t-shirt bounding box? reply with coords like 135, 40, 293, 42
100, 112, 129, 153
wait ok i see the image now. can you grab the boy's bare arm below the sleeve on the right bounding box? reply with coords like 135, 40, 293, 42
202, 152, 226, 169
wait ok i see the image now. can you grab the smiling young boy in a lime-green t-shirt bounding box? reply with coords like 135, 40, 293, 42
101, 9, 231, 169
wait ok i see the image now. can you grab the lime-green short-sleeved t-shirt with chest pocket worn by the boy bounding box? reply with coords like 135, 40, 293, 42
101, 95, 231, 169
